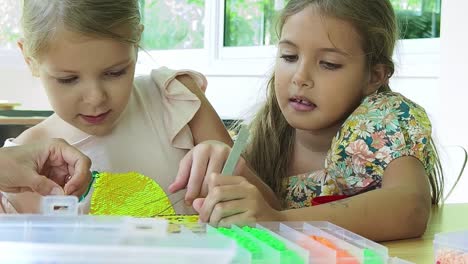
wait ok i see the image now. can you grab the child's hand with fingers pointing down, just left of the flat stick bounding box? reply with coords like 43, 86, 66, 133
169, 140, 245, 204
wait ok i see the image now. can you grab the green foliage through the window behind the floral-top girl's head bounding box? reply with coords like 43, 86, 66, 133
224, 0, 441, 47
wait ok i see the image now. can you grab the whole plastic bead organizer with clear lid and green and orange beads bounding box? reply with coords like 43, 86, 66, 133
0, 196, 408, 264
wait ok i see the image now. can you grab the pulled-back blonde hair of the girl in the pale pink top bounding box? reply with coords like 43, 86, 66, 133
21, 0, 142, 58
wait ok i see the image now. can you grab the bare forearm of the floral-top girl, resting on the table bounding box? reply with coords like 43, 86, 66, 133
278, 187, 430, 241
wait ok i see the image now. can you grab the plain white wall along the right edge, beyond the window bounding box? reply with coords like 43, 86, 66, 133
437, 0, 468, 201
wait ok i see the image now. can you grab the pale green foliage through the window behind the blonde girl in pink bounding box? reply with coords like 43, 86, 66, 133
0, 0, 205, 50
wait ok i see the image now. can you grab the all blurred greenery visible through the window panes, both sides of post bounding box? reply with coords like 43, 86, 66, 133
0, 0, 441, 50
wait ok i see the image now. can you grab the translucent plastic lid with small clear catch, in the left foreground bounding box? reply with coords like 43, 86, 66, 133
0, 196, 237, 264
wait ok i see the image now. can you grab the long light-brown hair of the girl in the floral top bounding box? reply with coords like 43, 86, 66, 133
244, 0, 443, 204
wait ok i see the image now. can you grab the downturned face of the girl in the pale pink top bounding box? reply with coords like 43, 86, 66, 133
24, 30, 137, 136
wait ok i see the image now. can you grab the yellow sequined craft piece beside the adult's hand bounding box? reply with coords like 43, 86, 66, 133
90, 172, 175, 217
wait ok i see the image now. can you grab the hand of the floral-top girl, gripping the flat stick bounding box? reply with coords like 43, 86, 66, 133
193, 173, 281, 227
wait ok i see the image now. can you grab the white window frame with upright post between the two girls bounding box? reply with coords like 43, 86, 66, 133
0, 0, 442, 78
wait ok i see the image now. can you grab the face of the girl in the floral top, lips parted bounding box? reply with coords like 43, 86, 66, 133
275, 6, 376, 132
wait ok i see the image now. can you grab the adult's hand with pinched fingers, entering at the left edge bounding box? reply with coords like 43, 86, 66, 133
0, 139, 91, 196
